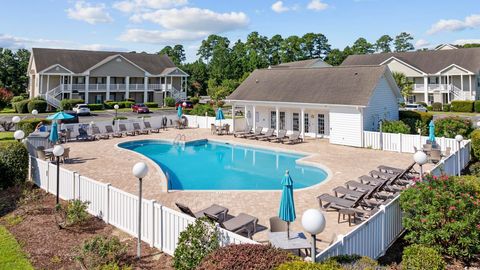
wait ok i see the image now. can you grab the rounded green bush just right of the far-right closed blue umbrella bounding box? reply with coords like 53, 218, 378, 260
435, 116, 473, 138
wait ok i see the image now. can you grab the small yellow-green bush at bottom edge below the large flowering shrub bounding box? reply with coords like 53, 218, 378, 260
402, 245, 445, 270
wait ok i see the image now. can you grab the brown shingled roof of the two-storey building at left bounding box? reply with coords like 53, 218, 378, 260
32, 48, 175, 75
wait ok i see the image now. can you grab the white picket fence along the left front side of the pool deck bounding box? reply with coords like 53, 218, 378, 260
30, 157, 257, 255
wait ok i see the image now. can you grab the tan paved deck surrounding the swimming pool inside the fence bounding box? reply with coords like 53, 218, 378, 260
65, 128, 422, 251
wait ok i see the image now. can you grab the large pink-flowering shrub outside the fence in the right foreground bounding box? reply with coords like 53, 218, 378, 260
400, 176, 480, 260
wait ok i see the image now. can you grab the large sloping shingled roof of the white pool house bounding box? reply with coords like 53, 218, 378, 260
227, 66, 400, 106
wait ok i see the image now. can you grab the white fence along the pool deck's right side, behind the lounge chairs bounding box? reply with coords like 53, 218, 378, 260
316, 141, 471, 261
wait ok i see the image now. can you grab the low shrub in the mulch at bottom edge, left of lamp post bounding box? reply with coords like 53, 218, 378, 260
76, 236, 127, 269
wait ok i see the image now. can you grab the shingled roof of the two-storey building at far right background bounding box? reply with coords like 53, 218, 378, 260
342, 48, 480, 74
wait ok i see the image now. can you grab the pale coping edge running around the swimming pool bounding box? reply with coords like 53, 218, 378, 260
115, 138, 333, 193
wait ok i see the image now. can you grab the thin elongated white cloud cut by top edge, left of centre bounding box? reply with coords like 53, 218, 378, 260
113, 0, 188, 13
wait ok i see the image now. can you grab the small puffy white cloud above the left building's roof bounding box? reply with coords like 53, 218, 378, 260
67, 1, 113, 24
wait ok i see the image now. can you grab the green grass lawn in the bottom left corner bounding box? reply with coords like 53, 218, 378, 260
0, 225, 33, 270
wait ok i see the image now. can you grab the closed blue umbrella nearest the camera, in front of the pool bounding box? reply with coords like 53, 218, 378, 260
278, 171, 296, 238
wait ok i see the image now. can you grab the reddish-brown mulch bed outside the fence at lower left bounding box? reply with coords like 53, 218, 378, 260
0, 188, 173, 269
